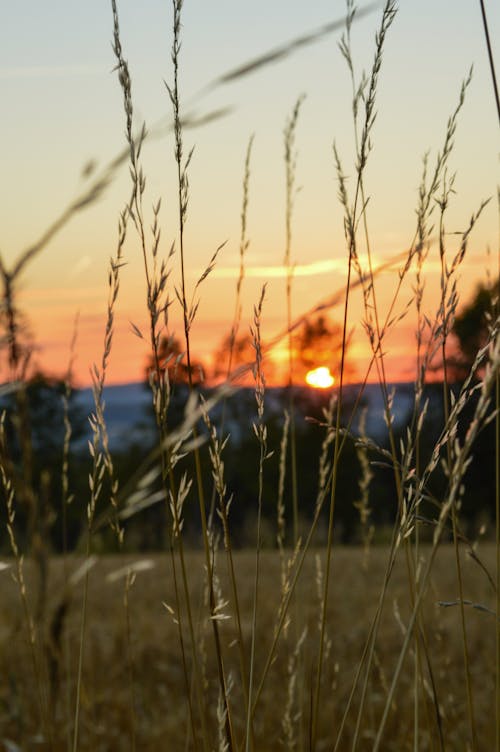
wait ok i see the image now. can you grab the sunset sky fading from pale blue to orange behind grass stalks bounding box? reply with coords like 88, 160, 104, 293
0, 0, 500, 386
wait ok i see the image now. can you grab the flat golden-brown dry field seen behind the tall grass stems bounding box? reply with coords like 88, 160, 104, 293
0, 544, 495, 752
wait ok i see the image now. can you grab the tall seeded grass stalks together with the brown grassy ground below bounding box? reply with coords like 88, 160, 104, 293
0, 0, 500, 752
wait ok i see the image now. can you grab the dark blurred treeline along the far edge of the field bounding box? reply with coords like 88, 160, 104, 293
0, 376, 495, 554
